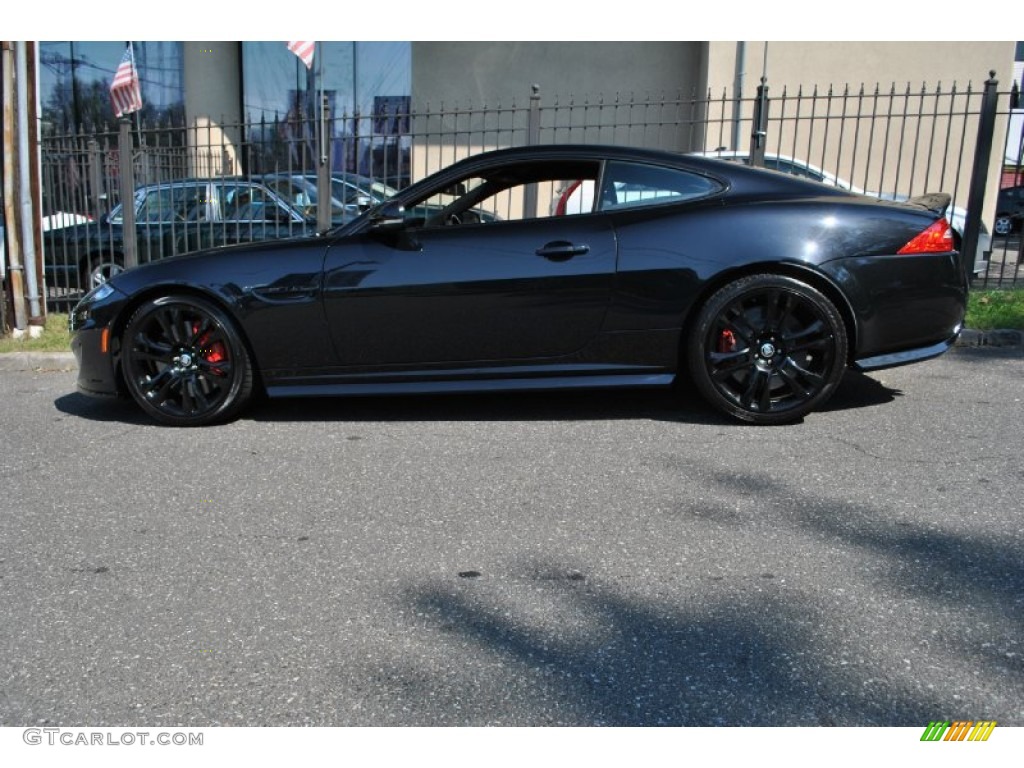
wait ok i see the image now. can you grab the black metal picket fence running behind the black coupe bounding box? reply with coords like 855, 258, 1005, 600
41, 72, 1024, 310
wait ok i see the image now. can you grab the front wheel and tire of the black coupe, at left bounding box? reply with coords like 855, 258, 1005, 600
121, 296, 253, 427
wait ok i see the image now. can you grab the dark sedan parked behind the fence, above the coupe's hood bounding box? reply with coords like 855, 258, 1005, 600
44, 177, 316, 290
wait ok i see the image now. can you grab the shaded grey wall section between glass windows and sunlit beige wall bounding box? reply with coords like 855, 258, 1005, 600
412, 41, 708, 179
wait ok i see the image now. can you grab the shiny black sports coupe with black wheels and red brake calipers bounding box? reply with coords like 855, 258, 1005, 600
71, 145, 967, 425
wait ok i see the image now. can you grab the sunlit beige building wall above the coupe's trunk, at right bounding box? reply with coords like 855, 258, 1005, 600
706, 41, 1015, 218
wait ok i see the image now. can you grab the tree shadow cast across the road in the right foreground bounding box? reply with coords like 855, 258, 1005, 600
389, 462, 1024, 727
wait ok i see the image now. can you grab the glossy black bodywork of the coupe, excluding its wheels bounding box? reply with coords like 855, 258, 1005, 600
72, 146, 967, 428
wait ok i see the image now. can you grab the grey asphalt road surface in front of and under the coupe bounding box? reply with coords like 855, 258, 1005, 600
0, 346, 1024, 727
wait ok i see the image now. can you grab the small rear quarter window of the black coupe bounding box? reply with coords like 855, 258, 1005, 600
598, 161, 722, 211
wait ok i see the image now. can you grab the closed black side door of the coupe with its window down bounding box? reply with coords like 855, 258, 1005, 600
324, 157, 616, 367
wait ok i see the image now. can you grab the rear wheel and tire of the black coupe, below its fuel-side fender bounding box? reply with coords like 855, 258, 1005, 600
687, 274, 847, 425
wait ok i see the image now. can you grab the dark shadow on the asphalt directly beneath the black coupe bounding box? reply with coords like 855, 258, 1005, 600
53, 371, 900, 425
